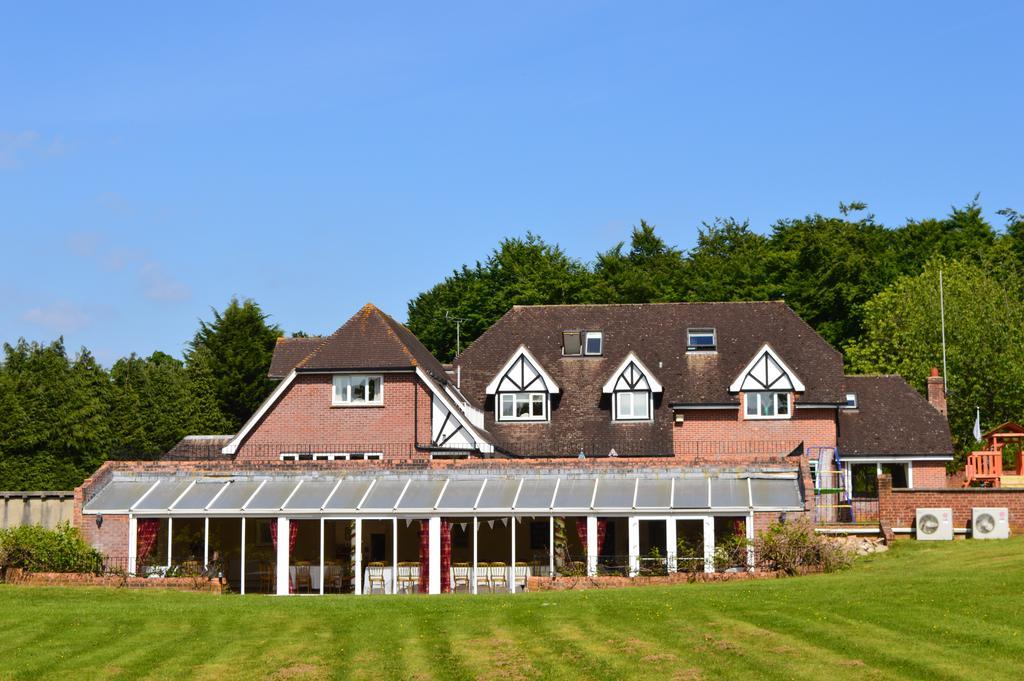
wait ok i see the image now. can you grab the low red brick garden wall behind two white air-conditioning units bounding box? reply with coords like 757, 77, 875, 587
879, 473, 1024, 533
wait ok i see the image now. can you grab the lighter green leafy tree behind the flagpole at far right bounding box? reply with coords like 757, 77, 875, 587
847, 257, 1024, 458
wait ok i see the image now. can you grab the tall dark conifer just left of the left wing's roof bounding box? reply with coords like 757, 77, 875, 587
185, 298, 282, 428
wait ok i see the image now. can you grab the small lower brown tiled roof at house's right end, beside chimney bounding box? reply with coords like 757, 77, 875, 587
839, 376, 952, 458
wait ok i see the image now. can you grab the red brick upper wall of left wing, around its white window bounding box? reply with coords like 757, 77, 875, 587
237, 374, 430, 461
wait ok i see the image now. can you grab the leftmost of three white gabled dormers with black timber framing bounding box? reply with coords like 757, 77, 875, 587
487, 346, 558, 421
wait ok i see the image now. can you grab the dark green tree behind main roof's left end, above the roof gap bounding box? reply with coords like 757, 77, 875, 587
408, 233, 591, 361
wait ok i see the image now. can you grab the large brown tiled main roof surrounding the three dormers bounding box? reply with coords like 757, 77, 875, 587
455, 302, 844, 451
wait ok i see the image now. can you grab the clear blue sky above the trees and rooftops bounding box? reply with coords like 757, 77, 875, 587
0, 2, 1024, 364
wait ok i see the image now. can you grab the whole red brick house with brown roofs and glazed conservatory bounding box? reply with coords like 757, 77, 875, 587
76, 302, 952, 594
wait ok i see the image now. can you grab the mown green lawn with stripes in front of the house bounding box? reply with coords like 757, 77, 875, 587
0, 538, 1024, 681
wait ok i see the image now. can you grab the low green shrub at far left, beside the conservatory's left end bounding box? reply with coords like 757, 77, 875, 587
0, 522, 103, 572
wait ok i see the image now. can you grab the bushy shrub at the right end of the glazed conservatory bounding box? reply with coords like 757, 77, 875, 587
754, 520, 853, 574
